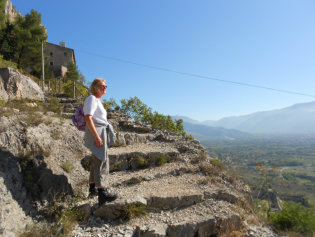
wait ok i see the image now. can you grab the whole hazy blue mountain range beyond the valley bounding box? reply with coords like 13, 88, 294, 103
174, 101, 315, 139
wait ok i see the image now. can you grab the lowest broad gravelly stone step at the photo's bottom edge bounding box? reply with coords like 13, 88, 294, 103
133, 200, 242, 237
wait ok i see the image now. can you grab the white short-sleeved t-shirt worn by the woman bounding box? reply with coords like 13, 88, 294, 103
83, 95, 108, 124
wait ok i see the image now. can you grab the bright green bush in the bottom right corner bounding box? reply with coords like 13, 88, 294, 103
270, 202, 315, 236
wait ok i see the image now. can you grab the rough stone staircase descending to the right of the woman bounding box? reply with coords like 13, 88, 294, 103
73, 112, 259, 237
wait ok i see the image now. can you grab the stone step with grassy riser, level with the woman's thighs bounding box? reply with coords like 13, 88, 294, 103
108, 143, 180, 171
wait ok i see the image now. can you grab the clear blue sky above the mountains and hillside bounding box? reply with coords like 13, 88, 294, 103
12, 0, 315, 121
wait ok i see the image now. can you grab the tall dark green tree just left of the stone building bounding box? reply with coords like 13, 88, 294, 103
13, 10, 47, 77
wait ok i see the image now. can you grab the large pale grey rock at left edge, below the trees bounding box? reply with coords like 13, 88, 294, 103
0, 68, 44, 101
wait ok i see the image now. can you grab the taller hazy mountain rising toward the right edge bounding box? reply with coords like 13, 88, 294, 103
207, 101, 315, 134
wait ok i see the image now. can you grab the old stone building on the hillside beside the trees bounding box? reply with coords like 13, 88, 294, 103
44, 42, 75, 77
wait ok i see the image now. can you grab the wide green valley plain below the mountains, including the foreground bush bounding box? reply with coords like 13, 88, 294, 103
204, 137, 315, 236
